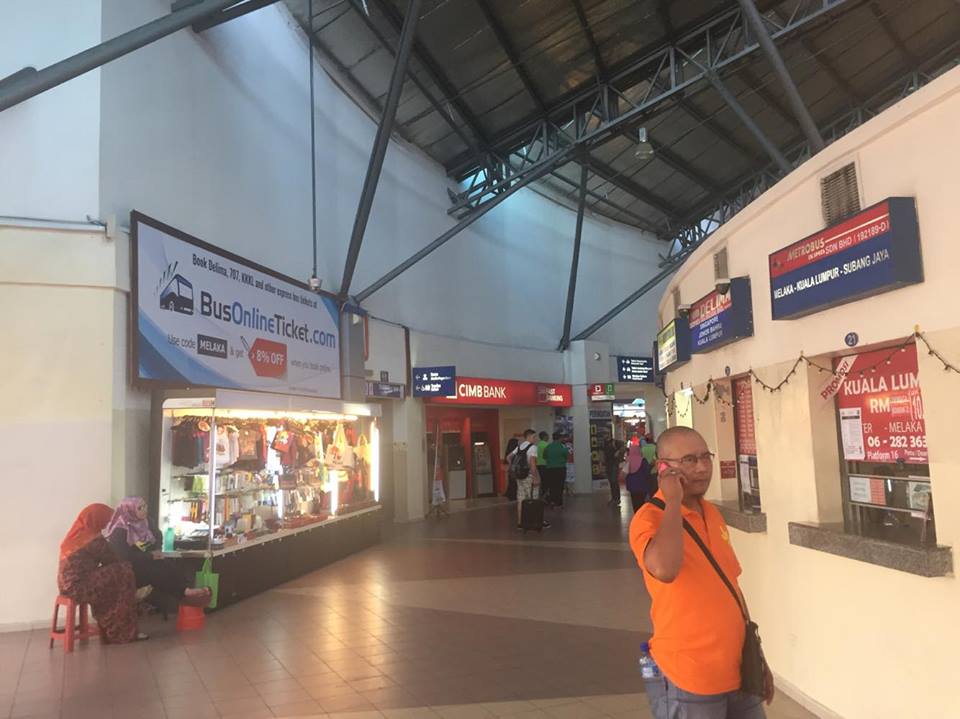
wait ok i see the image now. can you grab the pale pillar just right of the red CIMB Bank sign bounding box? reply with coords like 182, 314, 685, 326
563, 340, 610, 494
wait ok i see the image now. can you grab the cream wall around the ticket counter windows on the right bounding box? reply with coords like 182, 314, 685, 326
660, 69, 960, 719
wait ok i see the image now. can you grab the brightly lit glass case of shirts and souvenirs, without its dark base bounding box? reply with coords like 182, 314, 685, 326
153, 390, 380, 553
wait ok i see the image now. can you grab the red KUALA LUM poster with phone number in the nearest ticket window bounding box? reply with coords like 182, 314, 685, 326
834, 345, 927, 464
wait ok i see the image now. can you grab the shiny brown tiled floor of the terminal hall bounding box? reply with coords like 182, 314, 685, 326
0, 495, 811, 719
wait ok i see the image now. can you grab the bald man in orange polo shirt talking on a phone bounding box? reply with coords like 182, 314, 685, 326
630, 427, 773, 719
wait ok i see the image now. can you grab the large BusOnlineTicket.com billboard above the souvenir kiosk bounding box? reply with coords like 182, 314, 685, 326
130, 212, 340, 397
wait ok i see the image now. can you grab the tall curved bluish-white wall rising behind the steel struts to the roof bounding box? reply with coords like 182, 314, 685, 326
101, 0, 664, 360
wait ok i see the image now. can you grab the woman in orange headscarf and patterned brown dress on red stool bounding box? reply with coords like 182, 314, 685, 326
57, 504, 147, 644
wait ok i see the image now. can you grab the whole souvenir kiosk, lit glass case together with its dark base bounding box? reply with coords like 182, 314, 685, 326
150, 390, 380, 606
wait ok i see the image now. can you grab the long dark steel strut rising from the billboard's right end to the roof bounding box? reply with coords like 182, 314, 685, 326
340, 0, 421, 299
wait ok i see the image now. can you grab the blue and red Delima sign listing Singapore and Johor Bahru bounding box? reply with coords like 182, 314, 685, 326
687, 277, 753, 353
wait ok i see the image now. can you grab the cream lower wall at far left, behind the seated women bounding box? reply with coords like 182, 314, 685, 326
0, 226, 128, 630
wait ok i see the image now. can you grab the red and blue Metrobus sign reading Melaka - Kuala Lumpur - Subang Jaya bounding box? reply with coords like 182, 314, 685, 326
769, 197, 923, 320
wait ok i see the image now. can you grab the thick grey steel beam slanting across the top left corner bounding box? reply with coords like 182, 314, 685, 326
0, 0, 248, 112
